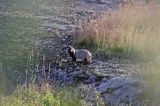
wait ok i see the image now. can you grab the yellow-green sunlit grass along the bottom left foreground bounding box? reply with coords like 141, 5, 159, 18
0, 84, 84, 106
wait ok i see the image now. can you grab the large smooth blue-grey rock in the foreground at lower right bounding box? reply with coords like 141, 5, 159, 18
97, 76, 147, 106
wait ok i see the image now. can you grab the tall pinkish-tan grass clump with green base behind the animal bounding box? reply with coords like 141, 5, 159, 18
75, 5, 160, 57
